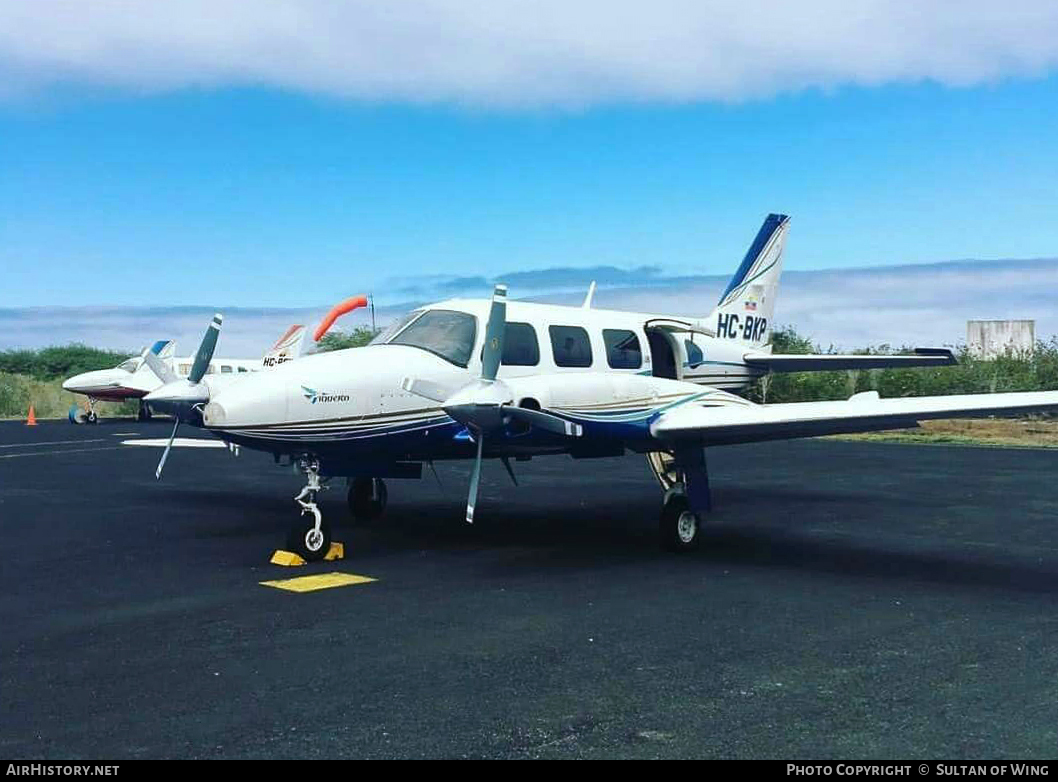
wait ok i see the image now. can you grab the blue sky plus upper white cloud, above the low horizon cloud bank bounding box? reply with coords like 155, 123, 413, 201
0, 0, 1058, 307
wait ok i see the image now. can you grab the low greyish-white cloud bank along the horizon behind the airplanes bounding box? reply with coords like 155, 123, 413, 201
6, 259, 1058, 358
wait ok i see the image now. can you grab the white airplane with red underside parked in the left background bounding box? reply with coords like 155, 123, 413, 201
62, 325, 305, 423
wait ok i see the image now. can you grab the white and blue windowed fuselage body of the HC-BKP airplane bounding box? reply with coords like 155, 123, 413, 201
198, 299, 763, 475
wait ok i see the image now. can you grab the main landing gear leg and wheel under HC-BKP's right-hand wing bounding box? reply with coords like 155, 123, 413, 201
647, 448, 712, 551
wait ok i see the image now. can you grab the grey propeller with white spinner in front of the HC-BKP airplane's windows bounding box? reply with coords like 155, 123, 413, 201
401, 285, 583, 524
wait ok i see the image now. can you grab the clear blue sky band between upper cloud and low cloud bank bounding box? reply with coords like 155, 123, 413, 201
0, 77, 1058, 306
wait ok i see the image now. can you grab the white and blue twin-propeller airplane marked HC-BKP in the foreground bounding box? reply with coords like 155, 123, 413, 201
146, 215, 1058, 560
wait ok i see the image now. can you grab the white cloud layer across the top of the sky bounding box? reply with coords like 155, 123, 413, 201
0, 0, 1058, 107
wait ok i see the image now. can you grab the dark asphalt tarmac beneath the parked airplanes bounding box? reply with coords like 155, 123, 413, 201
0, 421, 1058, 759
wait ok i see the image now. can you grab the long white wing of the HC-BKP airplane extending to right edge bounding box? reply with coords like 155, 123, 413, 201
651, 392, 1058, 445
